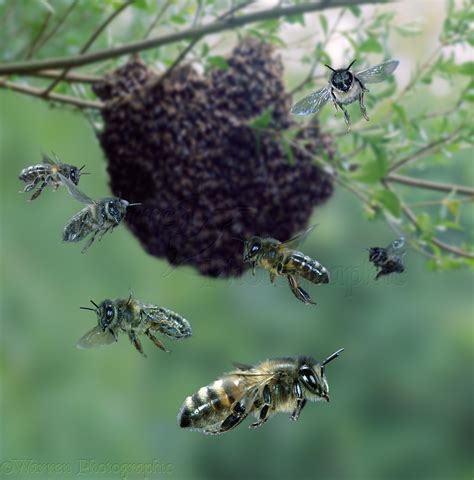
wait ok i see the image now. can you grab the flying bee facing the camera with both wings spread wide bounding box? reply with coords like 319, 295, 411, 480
291, 60, 399, 129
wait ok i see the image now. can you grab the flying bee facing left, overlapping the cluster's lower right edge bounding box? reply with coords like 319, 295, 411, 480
244, 225, 329, 305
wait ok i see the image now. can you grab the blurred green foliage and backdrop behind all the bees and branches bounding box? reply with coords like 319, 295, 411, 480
0, 0, 474, 480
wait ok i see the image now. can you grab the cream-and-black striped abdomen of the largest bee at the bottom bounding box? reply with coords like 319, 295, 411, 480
178, 375, 246, 433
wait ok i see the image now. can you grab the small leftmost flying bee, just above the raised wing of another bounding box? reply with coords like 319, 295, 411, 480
18, 153, 87, 201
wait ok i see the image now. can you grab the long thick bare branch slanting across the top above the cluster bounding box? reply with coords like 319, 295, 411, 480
0, 0, 388, 75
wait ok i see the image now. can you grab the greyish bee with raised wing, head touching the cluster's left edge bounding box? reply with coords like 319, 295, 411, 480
59, 174, 141, 253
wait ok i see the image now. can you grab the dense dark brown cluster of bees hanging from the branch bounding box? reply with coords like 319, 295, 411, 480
94, 40, 333, 277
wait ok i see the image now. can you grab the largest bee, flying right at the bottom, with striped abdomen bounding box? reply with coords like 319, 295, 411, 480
178, 348, 344, 434
